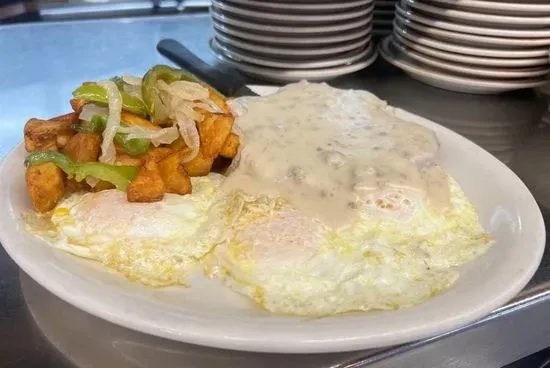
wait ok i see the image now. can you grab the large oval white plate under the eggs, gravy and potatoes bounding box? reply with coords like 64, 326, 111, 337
0, 86, 545, 353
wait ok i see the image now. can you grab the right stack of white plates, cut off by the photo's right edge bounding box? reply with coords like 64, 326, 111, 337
379, 0, 550, 94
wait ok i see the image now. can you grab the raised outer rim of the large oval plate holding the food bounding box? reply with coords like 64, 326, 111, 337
0, 85, 546, 353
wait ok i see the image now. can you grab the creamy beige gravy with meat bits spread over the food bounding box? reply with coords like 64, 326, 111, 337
225, 82, 450, 227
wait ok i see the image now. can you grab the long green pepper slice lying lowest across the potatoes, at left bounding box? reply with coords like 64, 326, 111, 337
25, 151, 138, 191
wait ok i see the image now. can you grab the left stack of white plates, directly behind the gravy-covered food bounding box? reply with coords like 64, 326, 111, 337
210, 0, 377, 82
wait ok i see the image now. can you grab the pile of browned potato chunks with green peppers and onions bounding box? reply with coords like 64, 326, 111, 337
24, 65, 240, 213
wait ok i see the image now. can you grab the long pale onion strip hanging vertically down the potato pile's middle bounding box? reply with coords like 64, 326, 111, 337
98, 80, 122, 164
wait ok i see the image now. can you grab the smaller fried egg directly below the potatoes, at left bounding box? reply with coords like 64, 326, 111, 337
27, 173, 223, 287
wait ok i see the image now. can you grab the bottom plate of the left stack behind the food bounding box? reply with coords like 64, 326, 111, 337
211, 48, 378, 83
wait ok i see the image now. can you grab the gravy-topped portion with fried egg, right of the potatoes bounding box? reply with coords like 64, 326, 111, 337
206, 83, 492, 316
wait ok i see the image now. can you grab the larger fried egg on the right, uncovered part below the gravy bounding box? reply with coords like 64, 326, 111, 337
207, 178, 492, 316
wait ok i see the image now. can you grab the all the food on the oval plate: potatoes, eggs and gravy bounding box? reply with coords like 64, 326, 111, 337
21, 75, 493, 316
